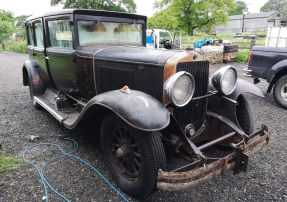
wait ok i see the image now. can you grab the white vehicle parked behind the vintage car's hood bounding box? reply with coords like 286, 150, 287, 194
146, 29, 182, 50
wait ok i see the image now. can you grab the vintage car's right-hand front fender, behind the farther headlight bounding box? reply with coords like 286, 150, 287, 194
209, 79, 264, 100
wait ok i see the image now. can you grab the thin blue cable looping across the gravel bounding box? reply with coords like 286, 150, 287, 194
23, 138, 129, 202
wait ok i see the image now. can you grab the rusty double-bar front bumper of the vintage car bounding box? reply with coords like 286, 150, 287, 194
157, 125, 270, 190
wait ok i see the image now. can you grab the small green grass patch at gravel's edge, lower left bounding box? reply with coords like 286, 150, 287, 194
0, 152, 22, 174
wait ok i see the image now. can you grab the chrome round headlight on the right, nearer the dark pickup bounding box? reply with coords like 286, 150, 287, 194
211, 66, 237, 95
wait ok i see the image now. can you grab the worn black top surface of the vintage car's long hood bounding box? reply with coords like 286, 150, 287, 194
76, 45, 181, 66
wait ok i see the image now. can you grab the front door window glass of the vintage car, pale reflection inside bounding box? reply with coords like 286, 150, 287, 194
48, 20, 73, 49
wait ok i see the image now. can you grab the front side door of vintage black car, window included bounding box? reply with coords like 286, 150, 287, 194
45, 17, 79, 94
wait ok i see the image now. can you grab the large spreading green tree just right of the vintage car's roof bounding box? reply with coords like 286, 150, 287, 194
148, 0, 235, 35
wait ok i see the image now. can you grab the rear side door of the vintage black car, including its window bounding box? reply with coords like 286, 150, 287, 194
26, 18, 52, 86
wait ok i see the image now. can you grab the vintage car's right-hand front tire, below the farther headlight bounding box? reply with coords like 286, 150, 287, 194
236, 95, 255, 135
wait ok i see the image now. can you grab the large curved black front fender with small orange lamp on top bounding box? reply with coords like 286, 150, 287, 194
70, 90, 170, 131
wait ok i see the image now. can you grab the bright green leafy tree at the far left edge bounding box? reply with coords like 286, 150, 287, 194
0, 10, 15, 50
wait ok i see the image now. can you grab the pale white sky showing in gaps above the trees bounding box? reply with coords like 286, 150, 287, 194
0, 0, 268, 17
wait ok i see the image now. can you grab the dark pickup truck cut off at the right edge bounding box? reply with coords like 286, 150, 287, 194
244, 46, 287, 109
